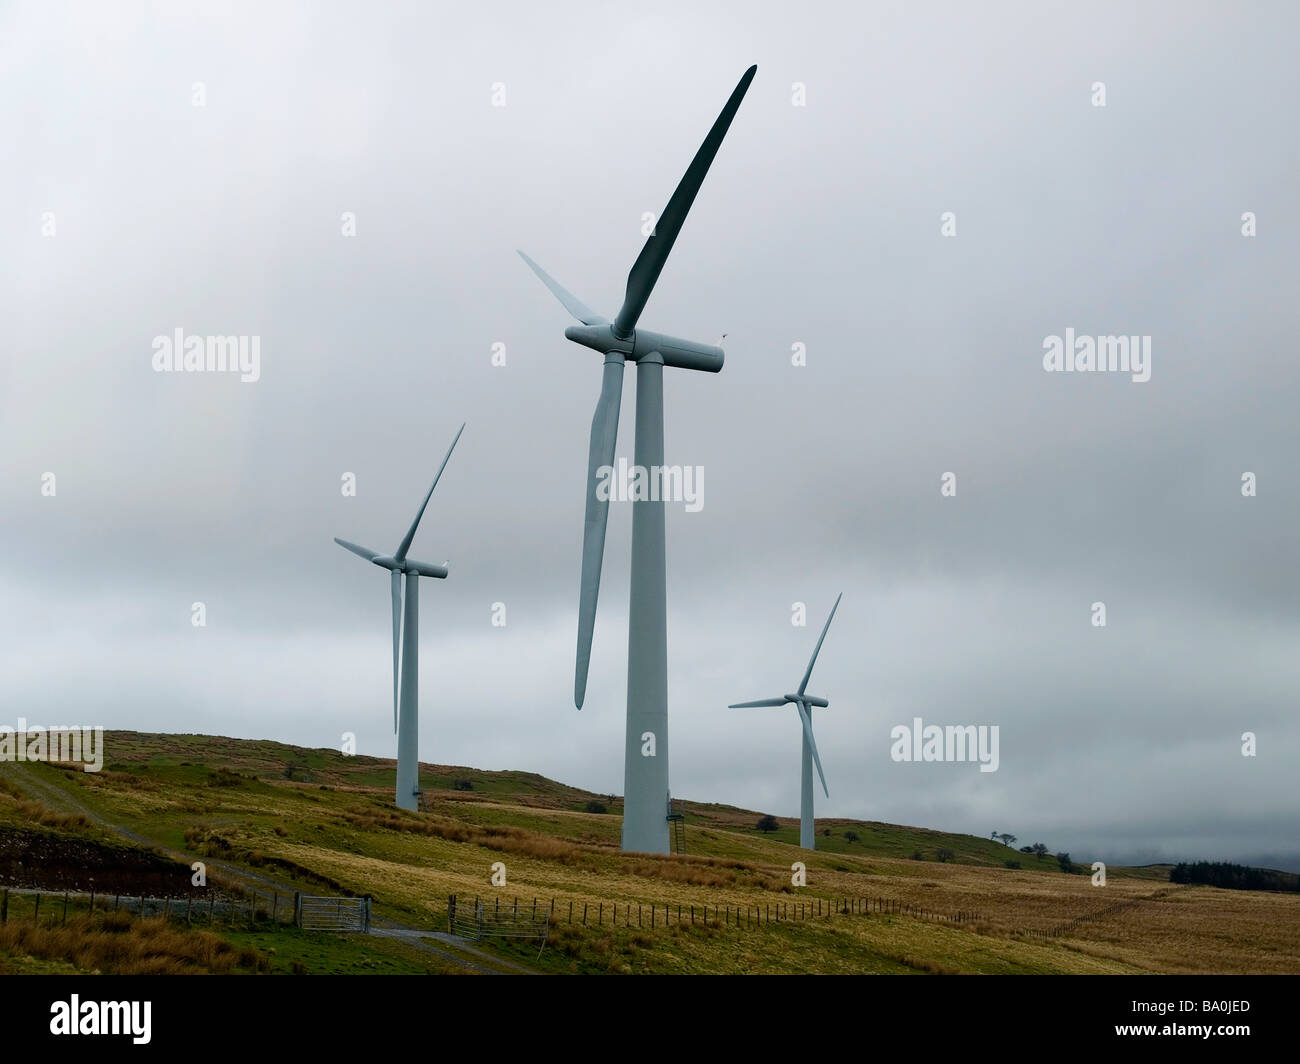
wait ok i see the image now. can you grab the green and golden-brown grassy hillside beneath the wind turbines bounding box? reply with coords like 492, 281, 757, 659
0, 732, 1300, 973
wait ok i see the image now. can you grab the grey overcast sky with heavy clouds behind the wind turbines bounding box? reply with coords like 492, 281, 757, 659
0, 0, 1300, 870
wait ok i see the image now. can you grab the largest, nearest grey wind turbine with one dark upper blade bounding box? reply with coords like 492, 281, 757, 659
519, 66, 758, 853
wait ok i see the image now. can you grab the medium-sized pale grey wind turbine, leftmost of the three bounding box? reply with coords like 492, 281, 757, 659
334, 425, 465, 809
